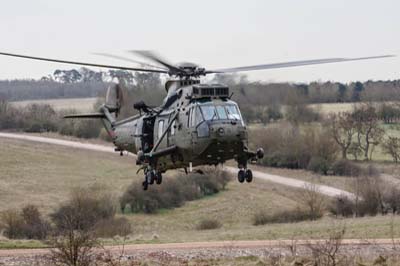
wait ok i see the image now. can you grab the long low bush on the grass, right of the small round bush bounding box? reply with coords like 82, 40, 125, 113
253, 209, 316, 225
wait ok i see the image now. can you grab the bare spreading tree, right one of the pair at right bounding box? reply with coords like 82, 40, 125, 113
352, 104, 385, 160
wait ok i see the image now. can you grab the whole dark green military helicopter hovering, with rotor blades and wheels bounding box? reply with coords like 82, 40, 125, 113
0, 51, 393, 190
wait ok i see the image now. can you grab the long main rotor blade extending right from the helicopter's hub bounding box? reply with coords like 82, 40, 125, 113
206, 55, 395, 74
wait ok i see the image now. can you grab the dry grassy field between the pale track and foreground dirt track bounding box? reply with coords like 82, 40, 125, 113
0, 139, 400, 247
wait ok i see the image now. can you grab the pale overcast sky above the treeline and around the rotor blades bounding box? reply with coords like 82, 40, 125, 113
0, 0, 400, 82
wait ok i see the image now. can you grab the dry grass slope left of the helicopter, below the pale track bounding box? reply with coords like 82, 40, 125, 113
0, 138, 135, 213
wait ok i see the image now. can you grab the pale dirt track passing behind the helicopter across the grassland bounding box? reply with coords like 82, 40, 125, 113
0, 133, 354, 198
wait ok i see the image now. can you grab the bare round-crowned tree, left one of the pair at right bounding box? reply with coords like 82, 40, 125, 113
329, 113, 356, 159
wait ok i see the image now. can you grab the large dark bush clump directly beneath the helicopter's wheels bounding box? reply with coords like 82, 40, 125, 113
120, 168, 230, 213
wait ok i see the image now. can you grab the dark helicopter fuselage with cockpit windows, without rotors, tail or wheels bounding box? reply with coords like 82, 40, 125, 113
112, 80, 249, 172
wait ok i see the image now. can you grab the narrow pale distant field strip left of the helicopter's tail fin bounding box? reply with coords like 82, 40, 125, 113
11, 97, 97, 112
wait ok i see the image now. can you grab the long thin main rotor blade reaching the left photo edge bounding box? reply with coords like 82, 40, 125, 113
0, 52, 168, 73
